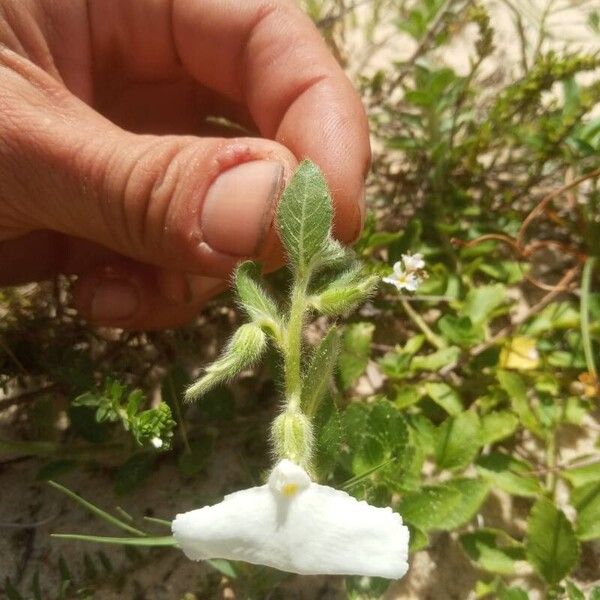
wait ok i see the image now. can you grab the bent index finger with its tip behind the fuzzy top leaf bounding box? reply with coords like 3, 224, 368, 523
172, 0, 370, 241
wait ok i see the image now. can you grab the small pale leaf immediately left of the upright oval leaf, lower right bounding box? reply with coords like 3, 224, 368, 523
460, 529, 525, 575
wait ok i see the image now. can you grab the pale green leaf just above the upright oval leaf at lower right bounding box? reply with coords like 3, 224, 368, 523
477, 452, 542, 498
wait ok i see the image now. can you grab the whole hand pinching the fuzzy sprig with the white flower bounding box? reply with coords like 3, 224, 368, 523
0, 0, 370, 329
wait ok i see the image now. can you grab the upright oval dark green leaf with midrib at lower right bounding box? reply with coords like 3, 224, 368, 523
526, 498, 579, 585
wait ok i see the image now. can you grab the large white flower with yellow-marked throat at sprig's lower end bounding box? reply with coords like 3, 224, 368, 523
172, 460, 409, 579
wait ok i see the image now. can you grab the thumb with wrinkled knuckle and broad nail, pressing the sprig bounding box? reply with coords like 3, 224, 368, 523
0, 50, 295, 277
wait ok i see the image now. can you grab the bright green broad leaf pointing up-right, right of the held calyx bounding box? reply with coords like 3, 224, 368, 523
435, 410, 481, 469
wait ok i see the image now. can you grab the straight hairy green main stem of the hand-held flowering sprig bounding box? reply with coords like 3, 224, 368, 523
284, 275, 308, 408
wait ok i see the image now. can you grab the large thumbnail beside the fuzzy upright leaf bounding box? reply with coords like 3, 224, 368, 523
201, 160, 283, 256
